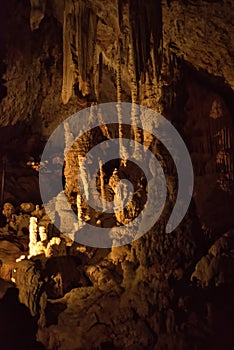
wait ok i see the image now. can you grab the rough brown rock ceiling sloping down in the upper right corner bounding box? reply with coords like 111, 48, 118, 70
162, 0, 234, 89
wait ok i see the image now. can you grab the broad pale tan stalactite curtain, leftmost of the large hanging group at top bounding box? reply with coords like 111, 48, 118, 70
62, 0, 97, 104
